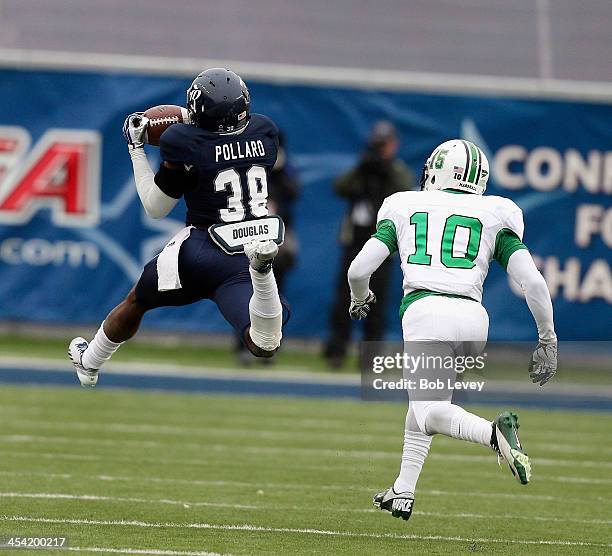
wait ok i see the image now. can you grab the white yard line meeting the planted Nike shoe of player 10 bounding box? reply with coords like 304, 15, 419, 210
0, 491, 612, 525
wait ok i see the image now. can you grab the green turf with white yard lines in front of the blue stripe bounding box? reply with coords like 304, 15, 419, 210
0, 386, 612, 555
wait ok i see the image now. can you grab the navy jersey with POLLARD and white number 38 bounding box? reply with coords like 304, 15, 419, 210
156, 114, 278, 227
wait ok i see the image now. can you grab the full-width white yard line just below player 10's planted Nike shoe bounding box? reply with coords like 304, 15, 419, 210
0, 515, 612, 548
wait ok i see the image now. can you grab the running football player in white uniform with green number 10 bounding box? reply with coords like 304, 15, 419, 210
348, 139, 557, 519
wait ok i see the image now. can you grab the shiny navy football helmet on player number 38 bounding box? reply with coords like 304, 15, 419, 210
187, 68, 251, 133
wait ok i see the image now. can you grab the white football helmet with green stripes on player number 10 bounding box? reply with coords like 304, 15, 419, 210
421, 139, 489, 195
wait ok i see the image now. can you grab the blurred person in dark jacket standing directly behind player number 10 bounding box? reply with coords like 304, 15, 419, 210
323, 121, 415, 368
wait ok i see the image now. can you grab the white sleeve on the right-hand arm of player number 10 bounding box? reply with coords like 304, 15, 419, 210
507, 249, 557, 343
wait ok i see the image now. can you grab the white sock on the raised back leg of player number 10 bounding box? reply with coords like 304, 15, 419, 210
425, 402, 491, 447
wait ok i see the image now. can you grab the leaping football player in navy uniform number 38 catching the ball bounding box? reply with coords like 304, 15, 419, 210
69, 68, 288, 387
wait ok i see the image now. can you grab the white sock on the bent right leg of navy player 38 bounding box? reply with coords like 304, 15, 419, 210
249, 268, 283, 351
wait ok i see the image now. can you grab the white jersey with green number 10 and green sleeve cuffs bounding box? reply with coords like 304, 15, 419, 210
375, 190, 524, 301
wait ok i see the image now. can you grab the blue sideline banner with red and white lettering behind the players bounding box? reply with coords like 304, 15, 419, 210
0, 70, 612, 340
